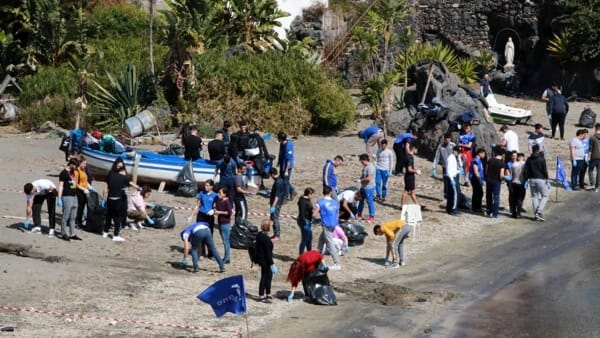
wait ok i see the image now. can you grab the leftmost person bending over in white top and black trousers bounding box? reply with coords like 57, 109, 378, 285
23, 178, 58, 233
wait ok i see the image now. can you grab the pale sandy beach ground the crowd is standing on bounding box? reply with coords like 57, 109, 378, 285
0, 95, 600, 337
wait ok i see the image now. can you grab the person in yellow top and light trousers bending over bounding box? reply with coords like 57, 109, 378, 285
373, 220, 412, 269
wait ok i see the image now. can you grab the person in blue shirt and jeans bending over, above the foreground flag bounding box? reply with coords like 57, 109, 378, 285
179, 222, 225, 272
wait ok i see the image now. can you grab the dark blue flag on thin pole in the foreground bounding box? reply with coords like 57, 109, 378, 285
198, 275, 246, 318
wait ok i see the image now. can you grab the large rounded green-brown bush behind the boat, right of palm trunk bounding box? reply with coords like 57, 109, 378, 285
190, 51, 355, 135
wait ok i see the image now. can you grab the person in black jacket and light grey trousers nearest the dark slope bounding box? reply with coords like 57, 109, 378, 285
524, 144, 549, 222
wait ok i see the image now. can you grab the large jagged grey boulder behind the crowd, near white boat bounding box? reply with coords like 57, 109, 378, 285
386, 62, 499, 158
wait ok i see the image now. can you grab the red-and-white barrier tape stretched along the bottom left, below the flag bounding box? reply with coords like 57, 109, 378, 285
0, 305, 241, 337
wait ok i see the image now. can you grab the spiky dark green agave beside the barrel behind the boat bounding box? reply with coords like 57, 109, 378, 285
90, 63, 140, 131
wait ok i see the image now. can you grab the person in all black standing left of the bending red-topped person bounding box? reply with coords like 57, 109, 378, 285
256, 219, 277, 303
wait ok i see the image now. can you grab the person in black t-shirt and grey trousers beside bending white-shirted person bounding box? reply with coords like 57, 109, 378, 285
57, 158, 81, 241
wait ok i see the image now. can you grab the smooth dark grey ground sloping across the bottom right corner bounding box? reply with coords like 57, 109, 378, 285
259, 192, 600, 337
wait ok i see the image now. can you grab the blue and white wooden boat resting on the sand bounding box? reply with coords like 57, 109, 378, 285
81, 147, 218, 185
